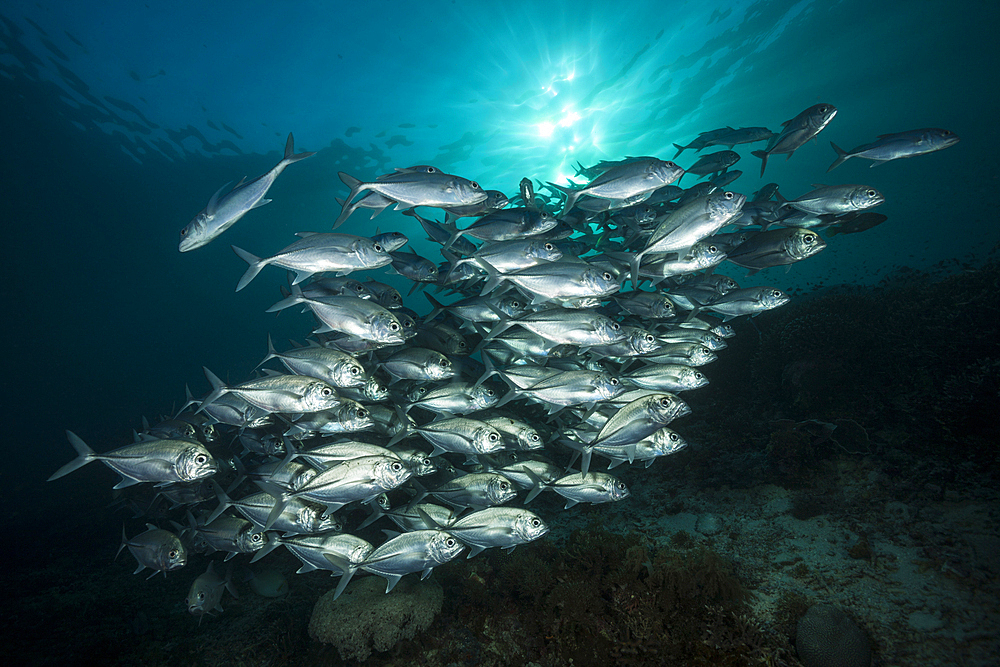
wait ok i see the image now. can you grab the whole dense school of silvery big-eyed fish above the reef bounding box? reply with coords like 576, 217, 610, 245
50, 104, 958, 617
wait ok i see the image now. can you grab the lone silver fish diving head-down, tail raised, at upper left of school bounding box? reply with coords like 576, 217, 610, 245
178, 132, 316, 252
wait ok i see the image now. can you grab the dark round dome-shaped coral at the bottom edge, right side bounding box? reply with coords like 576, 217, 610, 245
795, 604, 872, 667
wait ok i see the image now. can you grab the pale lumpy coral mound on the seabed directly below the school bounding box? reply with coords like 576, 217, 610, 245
309, 577, 444, 661
